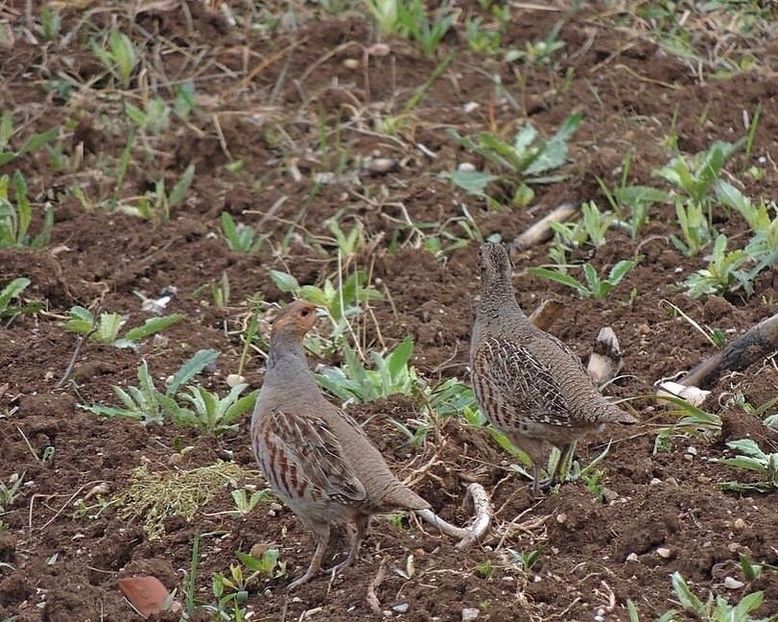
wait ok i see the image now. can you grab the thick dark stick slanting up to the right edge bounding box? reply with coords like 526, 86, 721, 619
679, 313, 778, 388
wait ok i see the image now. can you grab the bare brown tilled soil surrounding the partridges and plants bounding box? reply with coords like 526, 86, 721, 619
0, 2, 778, 622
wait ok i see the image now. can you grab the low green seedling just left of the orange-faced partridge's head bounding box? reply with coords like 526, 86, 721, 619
65, 306, 184, 348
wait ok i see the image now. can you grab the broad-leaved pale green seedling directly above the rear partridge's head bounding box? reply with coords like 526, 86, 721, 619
449, 113, 583, 206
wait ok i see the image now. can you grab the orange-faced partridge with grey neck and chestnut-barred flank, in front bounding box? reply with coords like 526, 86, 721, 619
251, 301, 430, 589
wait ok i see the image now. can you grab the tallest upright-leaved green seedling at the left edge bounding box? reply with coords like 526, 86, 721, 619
0, 172, 54, 248
